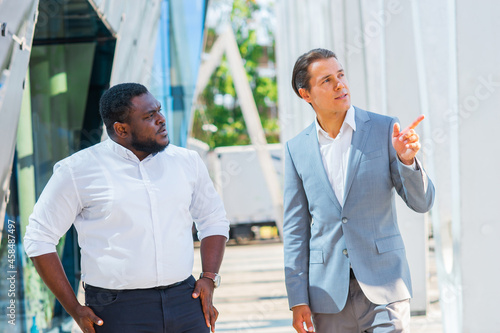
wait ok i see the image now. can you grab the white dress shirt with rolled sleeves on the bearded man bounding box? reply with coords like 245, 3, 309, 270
24, 139, 229, 289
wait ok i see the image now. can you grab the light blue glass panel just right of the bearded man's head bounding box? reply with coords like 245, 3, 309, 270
150, 0, 207, 147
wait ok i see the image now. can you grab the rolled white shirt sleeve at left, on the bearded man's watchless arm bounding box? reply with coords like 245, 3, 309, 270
24, 162, 82, 257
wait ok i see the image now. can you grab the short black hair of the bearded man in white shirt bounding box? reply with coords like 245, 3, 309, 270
99, 83, 149, 136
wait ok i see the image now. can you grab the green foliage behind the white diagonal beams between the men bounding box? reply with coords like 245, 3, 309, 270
192, 0, 279, 149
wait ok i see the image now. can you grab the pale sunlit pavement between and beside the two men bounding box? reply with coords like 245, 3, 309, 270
193, 241, 442, 333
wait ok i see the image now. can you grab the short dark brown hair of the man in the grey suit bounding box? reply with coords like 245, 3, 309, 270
292, 49, 338, 98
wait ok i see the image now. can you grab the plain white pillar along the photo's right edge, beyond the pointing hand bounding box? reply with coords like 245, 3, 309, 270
449, 0, 500, 332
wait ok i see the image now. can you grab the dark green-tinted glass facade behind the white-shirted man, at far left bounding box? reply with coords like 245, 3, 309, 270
0, 0, 116, 332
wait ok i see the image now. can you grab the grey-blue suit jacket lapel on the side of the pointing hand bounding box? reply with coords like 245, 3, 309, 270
344, 107, 371, 204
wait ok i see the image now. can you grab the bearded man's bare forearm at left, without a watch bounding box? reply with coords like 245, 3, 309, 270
31, 252, 81, 318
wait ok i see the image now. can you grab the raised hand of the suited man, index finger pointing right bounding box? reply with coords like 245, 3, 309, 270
392, 115, 424, 165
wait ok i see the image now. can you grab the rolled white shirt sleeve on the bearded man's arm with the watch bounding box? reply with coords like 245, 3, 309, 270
189, 152, 229, 240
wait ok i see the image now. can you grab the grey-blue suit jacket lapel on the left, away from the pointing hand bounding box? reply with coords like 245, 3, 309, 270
306, 123, 342, 212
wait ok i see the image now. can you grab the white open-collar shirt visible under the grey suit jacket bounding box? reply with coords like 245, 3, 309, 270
316, 105, 356, 206
